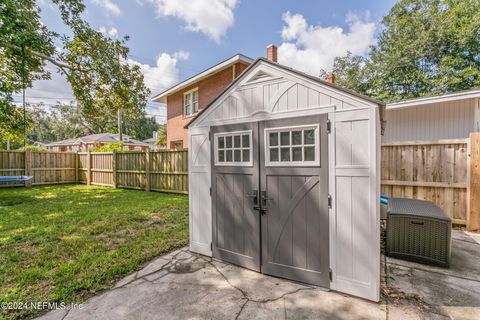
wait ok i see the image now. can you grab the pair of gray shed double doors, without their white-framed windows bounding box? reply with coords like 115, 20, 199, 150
211, 115, 330, 287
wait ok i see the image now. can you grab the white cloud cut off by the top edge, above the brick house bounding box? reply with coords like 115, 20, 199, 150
146, 0, 238, 42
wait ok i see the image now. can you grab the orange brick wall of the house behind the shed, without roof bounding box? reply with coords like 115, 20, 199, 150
167, 62, 248, 148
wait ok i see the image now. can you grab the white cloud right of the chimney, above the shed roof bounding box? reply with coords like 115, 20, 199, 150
278, 12, 375, 75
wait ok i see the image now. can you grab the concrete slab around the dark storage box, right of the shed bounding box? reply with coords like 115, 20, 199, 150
386, 230, 480, 319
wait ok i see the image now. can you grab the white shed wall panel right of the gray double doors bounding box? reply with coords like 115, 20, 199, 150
330, 109, 380, 301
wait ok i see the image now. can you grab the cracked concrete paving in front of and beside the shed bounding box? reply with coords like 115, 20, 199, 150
37, 234, 480, 320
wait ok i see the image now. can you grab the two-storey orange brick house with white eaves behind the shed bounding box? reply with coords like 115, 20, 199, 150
152, 54, 253, 149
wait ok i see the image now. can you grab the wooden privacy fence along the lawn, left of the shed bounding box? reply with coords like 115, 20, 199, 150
0, 150, 188, 193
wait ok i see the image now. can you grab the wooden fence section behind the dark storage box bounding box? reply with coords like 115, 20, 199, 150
381, 133, 480, 230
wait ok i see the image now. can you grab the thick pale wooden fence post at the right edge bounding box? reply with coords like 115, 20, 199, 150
467, 132, 480, 231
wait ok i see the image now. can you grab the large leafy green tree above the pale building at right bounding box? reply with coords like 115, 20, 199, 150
365, 0, 480, 101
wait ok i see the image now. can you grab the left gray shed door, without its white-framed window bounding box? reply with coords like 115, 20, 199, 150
211, 123, 260, 271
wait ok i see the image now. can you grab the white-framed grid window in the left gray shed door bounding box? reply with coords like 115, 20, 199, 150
215, 131, 252, 167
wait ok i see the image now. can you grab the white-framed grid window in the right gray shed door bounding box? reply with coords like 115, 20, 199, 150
265, 125, 320, 166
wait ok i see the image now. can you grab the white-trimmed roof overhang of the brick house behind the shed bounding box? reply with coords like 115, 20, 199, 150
152, 53, 253, 103
